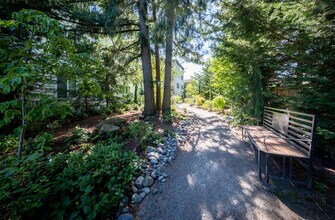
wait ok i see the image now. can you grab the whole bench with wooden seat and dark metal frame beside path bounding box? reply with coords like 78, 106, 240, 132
242, 107, 316, 187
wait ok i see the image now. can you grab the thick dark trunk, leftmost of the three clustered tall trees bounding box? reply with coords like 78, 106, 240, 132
138, 0, 155, 116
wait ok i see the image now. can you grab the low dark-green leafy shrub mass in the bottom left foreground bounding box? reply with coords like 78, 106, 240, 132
0, 143, 137, 219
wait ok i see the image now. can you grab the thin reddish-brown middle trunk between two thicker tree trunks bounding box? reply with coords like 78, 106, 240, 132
152, 0, 161, 112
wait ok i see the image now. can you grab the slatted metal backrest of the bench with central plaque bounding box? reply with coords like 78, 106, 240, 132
263, 107, 316, 157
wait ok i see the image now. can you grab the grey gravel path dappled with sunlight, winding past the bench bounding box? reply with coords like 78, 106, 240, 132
137, 105, 300, 220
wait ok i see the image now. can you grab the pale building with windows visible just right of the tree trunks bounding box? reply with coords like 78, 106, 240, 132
171, 60, 184, 97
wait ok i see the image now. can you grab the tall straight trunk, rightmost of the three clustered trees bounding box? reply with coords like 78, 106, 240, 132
162, 0, 175, 114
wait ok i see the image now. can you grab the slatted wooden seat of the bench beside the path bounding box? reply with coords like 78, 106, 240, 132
244, 126, 308, 158
